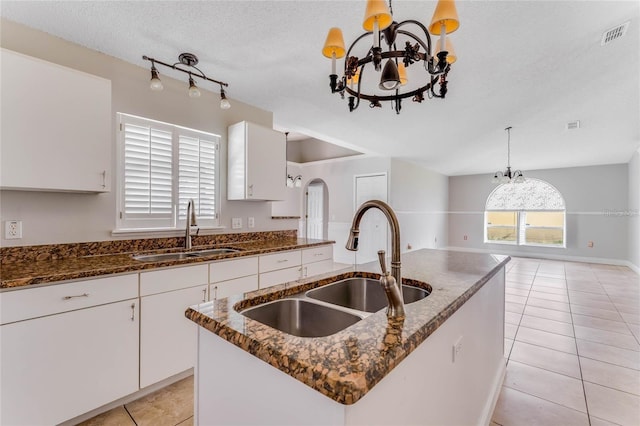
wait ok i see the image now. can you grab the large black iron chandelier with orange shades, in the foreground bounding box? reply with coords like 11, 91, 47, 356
322, 0, 460, 114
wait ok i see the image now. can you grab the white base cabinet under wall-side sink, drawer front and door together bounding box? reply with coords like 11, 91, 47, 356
140, 264, 208, 388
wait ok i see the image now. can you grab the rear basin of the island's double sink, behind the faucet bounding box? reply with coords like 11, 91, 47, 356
306, 278, 429, 312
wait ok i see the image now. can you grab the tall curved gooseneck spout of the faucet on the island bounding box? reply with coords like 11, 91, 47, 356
346, 200, 402, 300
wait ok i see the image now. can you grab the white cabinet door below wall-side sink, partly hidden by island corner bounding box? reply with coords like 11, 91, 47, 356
140, 285, 208, 388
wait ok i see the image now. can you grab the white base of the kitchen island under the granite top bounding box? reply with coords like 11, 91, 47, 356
195, 269, 505, 426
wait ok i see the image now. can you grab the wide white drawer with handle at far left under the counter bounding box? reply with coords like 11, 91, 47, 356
0, 274, 138, 324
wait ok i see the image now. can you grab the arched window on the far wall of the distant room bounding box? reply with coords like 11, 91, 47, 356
484, 178, 566, 247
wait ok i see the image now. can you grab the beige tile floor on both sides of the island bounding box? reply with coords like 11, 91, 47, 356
77, 258, 640, 426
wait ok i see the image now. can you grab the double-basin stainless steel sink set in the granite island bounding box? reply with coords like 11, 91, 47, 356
240, 277, 429, 337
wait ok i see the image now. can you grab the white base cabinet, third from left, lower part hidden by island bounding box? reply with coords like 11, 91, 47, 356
209, 257, 258, 300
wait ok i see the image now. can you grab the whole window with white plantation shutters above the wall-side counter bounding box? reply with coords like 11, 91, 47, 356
118, 114, 220, 229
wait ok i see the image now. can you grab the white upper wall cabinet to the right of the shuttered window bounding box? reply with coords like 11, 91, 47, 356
227, 121, 287, 200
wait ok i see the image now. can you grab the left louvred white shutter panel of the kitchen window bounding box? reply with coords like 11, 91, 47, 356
123, 123, 172, 218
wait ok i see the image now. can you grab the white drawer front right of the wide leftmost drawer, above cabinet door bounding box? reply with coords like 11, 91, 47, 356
140, 264, 209, 296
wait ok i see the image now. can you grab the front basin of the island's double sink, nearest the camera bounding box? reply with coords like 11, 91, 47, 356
241, 299, 362, 337
